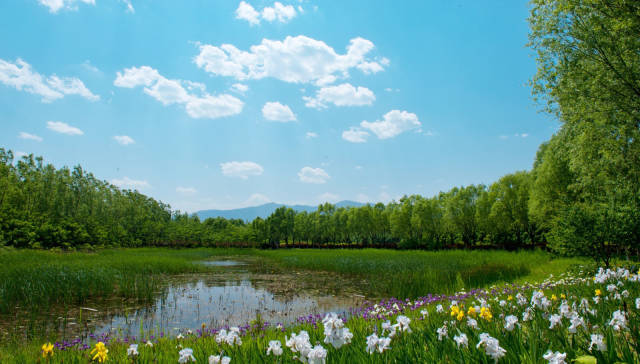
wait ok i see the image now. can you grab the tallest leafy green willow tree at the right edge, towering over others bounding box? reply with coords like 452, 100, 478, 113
529, 0, 640, 260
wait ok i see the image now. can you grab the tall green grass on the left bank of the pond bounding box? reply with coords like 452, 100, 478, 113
0, 248, 244, 313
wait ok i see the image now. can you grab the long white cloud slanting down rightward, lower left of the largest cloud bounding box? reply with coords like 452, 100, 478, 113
113, 66, 244, 119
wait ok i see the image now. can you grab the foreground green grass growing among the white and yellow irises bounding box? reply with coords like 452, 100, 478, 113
0, 266, 640, 364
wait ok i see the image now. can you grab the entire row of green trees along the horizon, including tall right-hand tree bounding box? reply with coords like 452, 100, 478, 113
0, 0, 640, 263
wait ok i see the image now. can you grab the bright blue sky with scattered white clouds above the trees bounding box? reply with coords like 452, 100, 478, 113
0, 0, 558, 212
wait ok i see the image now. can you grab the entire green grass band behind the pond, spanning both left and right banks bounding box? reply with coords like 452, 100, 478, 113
0, 248, 584, 313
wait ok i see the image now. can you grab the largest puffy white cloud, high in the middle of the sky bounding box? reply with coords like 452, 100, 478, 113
194, 35, 384, 85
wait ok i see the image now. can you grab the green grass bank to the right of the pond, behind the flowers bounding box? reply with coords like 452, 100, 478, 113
254, 249, 586, 299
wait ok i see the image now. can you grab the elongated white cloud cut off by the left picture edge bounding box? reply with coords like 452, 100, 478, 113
0, 58, 100, 102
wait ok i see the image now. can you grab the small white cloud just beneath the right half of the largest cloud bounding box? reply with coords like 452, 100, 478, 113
302, 83, 376, 109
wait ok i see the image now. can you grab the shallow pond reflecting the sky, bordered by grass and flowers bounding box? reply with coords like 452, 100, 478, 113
2, 258, 374, 340
